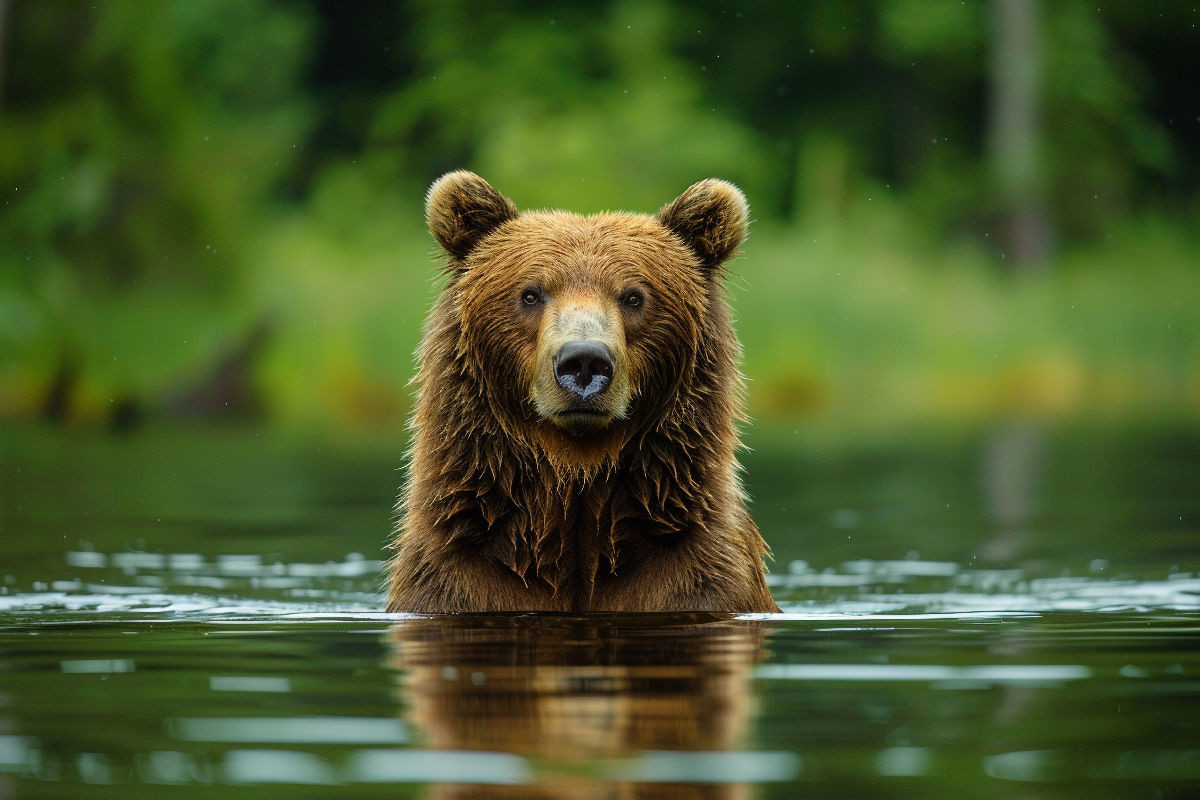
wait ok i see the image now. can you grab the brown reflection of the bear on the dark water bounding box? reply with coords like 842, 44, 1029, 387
391, 614, 763, 799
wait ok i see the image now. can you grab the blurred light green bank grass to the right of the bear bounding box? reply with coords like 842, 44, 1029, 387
733, 209, 1200, 429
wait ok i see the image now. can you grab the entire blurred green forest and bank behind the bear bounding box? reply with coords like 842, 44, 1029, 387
0, 0, 1200, 431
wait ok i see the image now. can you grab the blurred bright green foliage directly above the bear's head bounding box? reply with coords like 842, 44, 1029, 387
373, 2, 770, 211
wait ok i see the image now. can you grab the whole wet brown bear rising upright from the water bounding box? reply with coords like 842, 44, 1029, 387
388, 172, 779, 613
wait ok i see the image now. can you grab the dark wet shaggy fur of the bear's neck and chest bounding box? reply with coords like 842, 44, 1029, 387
404, 338, 744, 608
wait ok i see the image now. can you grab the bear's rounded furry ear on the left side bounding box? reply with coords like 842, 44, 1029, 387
425, 169, 518, 259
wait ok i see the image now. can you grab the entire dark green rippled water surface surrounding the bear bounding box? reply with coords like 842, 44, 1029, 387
0, 423, 1200, 798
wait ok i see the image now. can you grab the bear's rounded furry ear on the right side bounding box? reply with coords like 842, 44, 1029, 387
658, 178, 750, 269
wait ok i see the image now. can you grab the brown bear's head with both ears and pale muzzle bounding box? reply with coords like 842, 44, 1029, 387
422, 172, 748, 469
